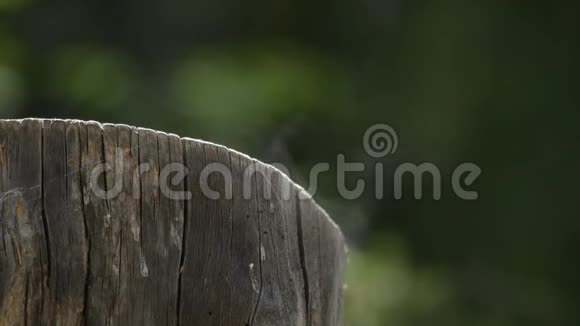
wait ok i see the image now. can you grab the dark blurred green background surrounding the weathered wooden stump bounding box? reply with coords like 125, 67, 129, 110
0, 0, 580, 326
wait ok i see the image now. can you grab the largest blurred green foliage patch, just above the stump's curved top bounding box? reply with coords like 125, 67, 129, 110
172, 47, 341, 143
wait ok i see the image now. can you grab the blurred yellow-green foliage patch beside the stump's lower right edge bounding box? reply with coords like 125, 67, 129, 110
345, 236, 451, 326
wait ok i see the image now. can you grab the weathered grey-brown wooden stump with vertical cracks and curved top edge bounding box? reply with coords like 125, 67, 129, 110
0, 119, 346, 326
